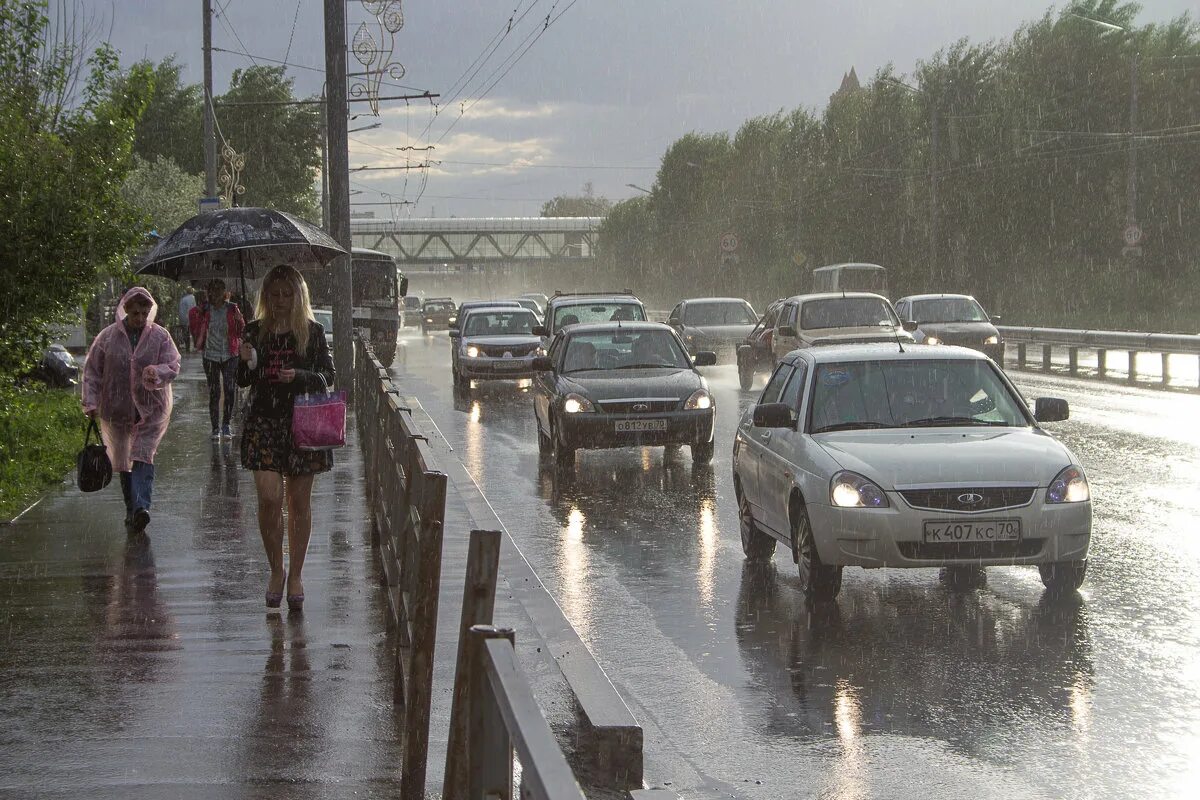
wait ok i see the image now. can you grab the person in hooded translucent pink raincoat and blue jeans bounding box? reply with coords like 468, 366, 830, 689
83, 287, 179, 531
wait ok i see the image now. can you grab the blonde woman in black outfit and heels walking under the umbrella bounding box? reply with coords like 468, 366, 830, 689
238, 264, 334, 610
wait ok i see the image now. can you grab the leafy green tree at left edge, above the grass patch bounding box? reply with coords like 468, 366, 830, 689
0, 0, 154, 383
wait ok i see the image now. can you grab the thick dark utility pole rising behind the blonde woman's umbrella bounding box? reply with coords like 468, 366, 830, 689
325, 0, 354, 393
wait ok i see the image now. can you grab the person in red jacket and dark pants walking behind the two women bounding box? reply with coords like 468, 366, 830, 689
196, 278, 246, 439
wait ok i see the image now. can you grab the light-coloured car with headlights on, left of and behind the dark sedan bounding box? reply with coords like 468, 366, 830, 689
450, 303, 541, 389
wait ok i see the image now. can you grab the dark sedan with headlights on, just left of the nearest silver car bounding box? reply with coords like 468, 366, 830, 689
533, 321, 716, 468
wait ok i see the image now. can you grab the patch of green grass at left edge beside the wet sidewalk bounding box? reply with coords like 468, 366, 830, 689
0, 385, 84, 522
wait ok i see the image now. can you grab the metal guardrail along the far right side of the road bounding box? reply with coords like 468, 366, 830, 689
997, 325, 1200, 384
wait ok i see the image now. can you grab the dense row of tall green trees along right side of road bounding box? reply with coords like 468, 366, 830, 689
599, 0, 1200, 331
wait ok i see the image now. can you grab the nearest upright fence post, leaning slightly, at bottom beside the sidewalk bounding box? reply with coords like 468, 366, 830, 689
442, 530, 500, 800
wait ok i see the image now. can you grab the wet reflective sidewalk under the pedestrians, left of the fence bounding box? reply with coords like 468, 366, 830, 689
0, 355, 405, 800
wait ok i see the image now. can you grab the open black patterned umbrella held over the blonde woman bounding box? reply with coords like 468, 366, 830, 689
137, 207, 346, 284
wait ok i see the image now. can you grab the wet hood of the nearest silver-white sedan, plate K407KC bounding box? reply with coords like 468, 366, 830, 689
812, 428, 1073, 489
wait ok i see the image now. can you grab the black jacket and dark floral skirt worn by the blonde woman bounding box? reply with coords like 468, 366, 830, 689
238, 319, 335, 475
